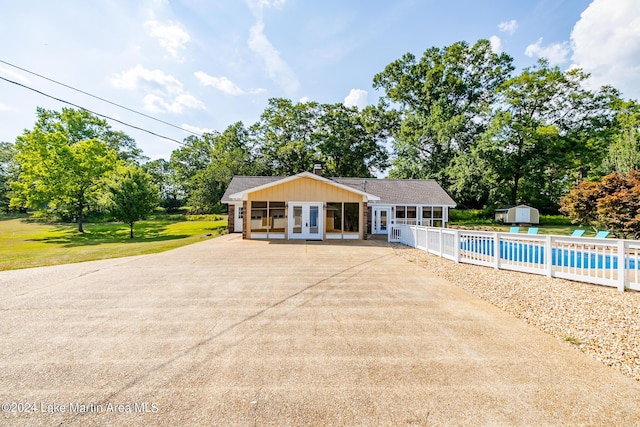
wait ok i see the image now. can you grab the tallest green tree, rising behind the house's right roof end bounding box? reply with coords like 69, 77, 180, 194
373, 40, 514, 204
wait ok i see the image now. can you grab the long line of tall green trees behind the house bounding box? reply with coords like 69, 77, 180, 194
0, 40, 640, 227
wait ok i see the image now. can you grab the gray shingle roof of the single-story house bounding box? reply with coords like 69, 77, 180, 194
221, 176, 456, 206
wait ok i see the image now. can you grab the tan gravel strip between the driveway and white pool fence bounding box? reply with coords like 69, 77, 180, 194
392, 244, 640, 381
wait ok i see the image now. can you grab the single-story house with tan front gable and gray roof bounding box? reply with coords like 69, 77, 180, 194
221, 172, 456, 240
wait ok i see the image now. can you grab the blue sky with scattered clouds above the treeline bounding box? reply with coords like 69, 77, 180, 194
0, 0, 640, 159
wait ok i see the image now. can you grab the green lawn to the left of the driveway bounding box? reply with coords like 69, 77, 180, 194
0, 216, 227, 270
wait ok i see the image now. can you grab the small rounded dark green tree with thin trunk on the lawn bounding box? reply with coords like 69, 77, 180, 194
107, 164, 159, 239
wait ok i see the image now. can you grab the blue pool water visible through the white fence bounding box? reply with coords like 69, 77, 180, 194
460, 239, 640, 270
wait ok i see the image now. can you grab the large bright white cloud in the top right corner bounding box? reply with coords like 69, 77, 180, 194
571, 0, 640, 99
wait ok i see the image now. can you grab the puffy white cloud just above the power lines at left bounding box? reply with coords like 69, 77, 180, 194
111, 64, 205, 114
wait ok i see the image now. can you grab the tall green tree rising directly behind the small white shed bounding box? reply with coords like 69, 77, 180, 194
478, 60, 610, 210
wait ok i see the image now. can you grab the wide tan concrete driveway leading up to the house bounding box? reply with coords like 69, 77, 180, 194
0, 235, 640, 426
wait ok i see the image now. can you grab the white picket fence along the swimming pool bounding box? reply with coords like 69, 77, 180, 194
389, 224, 640, 291
